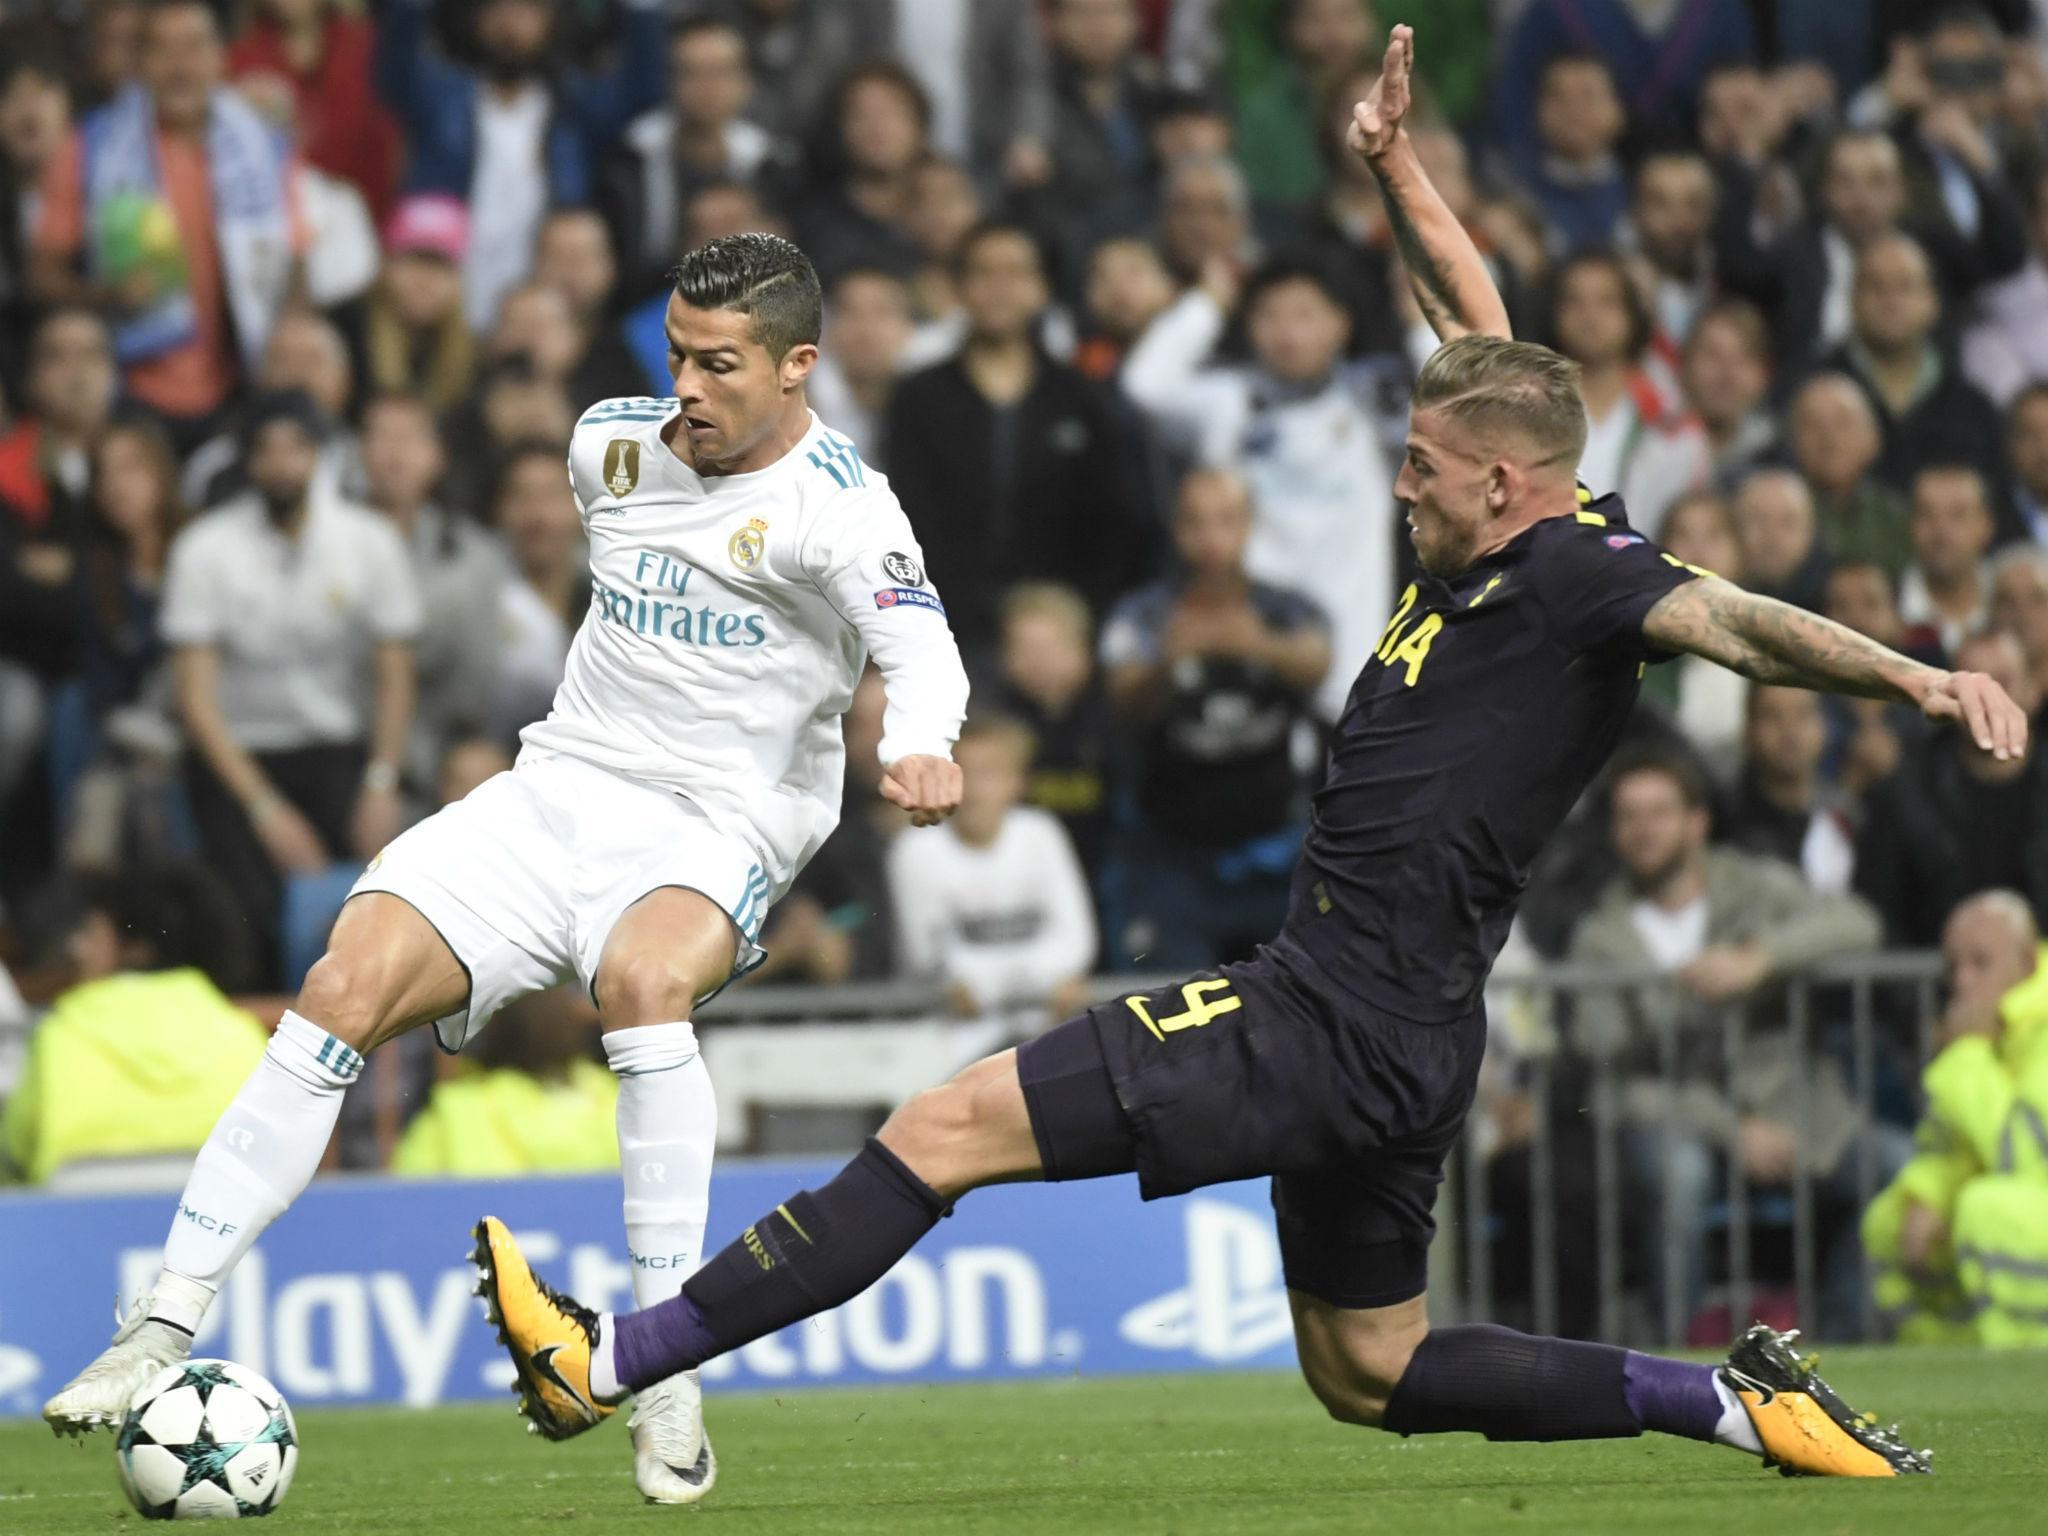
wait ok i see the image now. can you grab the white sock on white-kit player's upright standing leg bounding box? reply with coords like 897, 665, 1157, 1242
604, 1036, 719, 1307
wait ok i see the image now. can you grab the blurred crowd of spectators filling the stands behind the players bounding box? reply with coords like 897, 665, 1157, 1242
0, 0, 2048, 1343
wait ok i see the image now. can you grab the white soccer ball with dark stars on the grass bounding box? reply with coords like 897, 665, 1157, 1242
115, 1360, 299, 1520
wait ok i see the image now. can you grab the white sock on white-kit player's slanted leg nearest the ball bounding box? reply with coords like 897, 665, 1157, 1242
150, 1010, 362, 1333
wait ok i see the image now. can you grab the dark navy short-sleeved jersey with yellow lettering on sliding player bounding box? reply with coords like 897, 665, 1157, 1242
1280, 492, 1706, 1024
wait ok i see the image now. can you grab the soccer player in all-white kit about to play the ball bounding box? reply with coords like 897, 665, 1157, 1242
43, 233, 967, 1503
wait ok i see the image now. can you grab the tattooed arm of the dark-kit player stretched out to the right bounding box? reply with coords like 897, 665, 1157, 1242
1642, 578, 2028, 760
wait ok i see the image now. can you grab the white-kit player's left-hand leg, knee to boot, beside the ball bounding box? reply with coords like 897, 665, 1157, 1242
43, 895, 469, 1434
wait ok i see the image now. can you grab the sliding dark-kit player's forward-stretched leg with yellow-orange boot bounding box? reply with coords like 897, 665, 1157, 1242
475, 1018, 1135, 1440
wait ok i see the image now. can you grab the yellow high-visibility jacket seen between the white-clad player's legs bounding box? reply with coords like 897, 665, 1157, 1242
391, 1061, 618, 1178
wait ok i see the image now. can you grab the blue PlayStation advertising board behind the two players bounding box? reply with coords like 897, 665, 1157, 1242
0, 1161, 1294, 1417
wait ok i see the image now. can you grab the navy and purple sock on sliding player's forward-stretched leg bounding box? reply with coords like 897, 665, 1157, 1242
612, 1139, 948, 1391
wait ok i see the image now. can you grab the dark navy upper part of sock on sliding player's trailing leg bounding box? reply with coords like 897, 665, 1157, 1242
1382, 1323, 1642, 1440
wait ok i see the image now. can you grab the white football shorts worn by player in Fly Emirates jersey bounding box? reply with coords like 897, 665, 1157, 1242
348, 758, 776, 1051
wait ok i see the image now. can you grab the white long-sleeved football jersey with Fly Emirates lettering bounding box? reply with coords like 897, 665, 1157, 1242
520, 397, 967, 895
